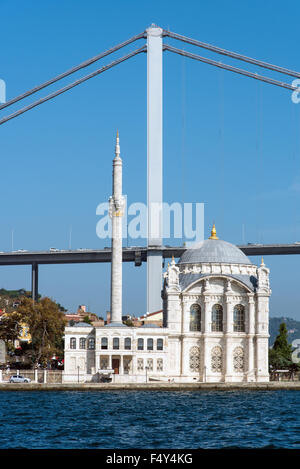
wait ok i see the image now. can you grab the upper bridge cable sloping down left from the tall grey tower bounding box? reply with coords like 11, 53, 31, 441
0, 32, 145, 110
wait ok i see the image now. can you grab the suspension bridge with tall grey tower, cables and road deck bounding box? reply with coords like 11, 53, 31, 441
0, 25, 300, 312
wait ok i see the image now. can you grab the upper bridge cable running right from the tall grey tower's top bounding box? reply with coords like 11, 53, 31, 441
164, 30, 300, 78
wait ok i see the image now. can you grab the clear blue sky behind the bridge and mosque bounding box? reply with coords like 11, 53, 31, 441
0, 0, 300, 319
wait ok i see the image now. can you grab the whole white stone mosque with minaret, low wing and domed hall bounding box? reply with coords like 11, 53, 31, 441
63, 135, 271, 383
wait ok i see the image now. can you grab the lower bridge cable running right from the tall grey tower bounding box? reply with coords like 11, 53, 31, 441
164, 44, 300, 91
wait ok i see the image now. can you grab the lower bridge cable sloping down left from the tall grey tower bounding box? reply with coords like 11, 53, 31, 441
0, 45, 147, 125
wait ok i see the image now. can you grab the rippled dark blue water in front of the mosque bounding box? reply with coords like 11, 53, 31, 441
0, 391, 300, 449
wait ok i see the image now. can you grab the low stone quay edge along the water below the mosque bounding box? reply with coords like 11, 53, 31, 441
0, 381, 300, 392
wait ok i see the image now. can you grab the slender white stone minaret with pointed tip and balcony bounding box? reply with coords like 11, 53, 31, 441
109, 132, 124, 327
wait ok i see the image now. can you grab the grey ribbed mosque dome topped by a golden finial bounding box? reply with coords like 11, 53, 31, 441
179, 225, 252, 265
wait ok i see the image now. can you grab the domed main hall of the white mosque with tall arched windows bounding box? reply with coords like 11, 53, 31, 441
163, 228, 271, 382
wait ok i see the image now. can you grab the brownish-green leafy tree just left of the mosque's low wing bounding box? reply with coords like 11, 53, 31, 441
18, 297, 65, 365
